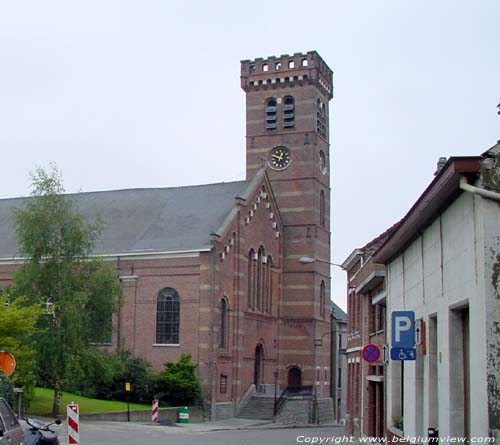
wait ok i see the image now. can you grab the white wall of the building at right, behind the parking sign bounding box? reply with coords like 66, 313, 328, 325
387, 193, 494, 436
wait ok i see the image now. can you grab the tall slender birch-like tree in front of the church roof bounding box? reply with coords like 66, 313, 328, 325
14, 166, 121, 414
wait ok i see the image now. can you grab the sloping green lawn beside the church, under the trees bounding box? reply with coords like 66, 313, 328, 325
28, 388, 151, 416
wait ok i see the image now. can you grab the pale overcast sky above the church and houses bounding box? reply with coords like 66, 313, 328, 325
0, 0, 500, 308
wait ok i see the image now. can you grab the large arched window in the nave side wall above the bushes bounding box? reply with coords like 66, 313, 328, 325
156, 287, 179, 345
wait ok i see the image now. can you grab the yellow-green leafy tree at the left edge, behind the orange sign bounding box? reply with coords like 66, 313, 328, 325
0, 290, 42, 401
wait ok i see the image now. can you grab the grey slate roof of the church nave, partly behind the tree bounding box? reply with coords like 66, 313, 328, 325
0, 181, 248, 259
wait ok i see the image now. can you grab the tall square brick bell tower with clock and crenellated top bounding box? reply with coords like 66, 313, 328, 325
241, 51, 333, 397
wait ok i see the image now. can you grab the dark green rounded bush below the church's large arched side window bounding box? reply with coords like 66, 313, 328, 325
160, 354, 201, 405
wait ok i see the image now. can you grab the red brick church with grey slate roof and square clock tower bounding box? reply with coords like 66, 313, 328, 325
0, 51, 333, 418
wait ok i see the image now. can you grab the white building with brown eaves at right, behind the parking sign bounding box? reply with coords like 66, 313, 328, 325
375, 144, 500, 441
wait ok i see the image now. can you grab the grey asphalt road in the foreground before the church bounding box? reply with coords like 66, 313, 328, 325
56, 422, 343, 445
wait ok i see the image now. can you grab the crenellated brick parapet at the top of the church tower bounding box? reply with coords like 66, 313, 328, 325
241, 51, 333, 100
